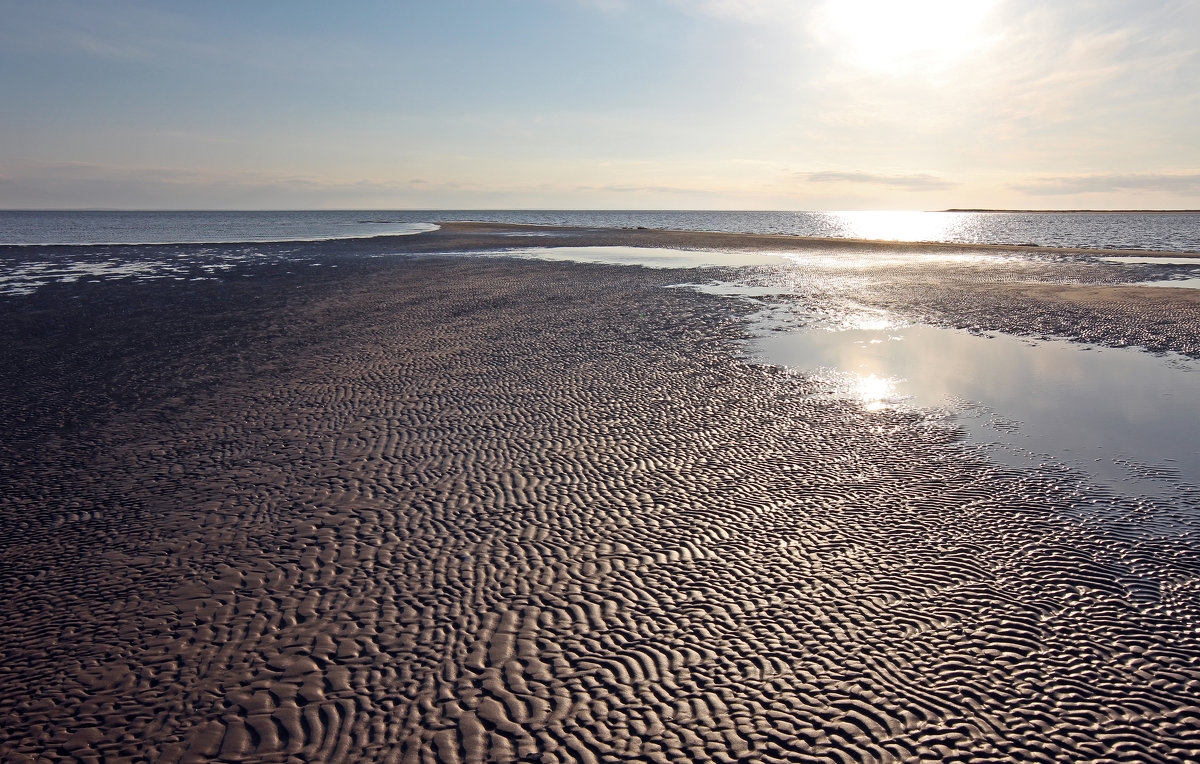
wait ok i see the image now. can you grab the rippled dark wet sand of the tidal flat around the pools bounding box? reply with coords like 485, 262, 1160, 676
0, 227, 1200, 763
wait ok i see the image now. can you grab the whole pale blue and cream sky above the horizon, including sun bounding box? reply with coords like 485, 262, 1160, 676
0, 0, 1200, 210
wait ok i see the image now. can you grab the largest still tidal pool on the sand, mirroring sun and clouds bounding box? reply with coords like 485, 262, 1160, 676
751, 315, 1200, 495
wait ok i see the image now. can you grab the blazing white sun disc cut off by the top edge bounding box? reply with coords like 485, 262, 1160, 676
815, 0, 995, 74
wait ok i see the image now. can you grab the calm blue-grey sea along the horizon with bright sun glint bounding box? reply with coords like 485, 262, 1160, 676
0, 210, 1200, 252
